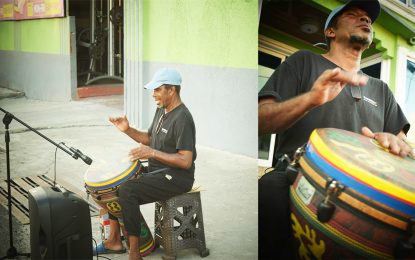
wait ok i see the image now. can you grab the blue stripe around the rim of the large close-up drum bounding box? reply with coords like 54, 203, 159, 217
306, 143, 415, 216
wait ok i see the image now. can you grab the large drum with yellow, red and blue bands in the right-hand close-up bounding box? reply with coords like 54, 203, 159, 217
290, 128, 415, 259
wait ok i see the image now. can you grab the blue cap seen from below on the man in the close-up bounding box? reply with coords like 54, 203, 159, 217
324, 0, 380, 31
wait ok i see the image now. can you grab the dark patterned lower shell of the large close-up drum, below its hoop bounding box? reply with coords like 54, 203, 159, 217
290, 170, 405, 259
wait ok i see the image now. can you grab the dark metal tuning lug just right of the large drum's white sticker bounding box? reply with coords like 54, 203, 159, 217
317, 179, 344, 223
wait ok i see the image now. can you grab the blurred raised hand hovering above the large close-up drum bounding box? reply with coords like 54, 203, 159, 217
310, 68, 368, 106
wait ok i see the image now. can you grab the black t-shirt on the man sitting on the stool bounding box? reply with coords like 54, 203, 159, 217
148, 103, 197, 182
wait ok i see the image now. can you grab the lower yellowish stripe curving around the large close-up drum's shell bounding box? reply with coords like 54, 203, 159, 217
290, 186, 392, 259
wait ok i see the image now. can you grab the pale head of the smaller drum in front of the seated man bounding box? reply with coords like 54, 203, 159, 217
84, 154, 141, 190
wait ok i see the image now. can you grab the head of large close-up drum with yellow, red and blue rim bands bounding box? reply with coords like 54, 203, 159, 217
305, 128, 415, 216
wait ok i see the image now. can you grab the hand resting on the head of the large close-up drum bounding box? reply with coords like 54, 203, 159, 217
362, 127, 415, 159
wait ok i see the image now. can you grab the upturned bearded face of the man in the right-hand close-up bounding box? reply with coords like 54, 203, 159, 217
335, 7, 373, 48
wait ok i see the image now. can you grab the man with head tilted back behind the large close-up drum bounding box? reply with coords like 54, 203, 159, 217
258, 0, 415, 259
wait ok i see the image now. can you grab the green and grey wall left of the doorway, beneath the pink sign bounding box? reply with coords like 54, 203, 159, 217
0, 18, 76, 101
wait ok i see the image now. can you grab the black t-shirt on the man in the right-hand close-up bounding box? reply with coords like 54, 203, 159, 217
259, 51, 409, 156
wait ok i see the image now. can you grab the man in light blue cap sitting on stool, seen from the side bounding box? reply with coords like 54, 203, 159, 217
108, 68, 196, 260
